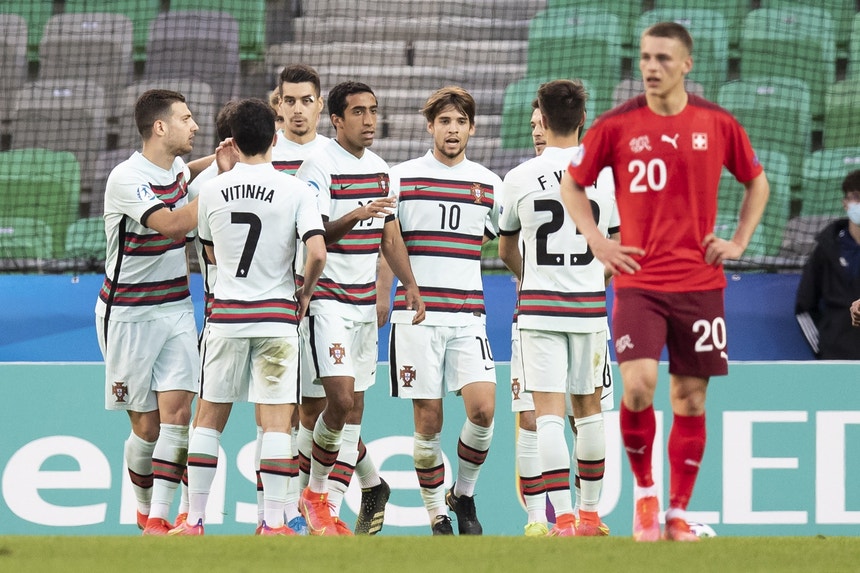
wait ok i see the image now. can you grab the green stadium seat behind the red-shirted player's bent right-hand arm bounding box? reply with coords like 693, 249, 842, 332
714, 150, 791, 259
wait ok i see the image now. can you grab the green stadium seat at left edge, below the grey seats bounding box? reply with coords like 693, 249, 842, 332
0, 149, 81, 257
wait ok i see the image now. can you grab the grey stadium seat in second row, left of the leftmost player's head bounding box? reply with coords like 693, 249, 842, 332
12, 79, 107, 185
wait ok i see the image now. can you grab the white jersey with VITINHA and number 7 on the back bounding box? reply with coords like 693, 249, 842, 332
198, 163, 325, 337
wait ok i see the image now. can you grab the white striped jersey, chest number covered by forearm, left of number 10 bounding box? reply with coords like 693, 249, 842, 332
296, 140, 394, 322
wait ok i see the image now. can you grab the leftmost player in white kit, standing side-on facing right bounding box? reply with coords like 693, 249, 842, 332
95, 90, 222, 535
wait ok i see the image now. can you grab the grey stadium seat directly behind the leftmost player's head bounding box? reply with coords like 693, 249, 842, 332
117, 78, 221, 160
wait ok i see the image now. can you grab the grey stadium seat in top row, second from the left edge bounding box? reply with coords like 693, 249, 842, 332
39, 12, 134, 110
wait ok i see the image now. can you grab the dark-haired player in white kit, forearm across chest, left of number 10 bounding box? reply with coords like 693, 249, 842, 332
296, 81, 424, 535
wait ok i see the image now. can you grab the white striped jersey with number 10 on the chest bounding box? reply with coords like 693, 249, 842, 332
391, 151, 502, 326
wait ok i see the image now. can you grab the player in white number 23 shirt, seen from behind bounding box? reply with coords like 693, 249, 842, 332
499, 80, 619, 536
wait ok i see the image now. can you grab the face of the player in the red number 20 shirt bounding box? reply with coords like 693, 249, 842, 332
639, 36, 693, 97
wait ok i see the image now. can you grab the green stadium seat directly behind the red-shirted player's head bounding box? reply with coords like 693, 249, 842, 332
637, 8, 729, 99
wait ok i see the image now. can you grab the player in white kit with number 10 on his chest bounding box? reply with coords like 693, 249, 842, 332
380, 86, 502, 535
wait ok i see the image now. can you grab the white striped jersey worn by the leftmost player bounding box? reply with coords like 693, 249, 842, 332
96, 151, 194, 322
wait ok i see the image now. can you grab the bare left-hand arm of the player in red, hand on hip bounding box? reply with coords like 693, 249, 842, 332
561, 170, 645, 275
